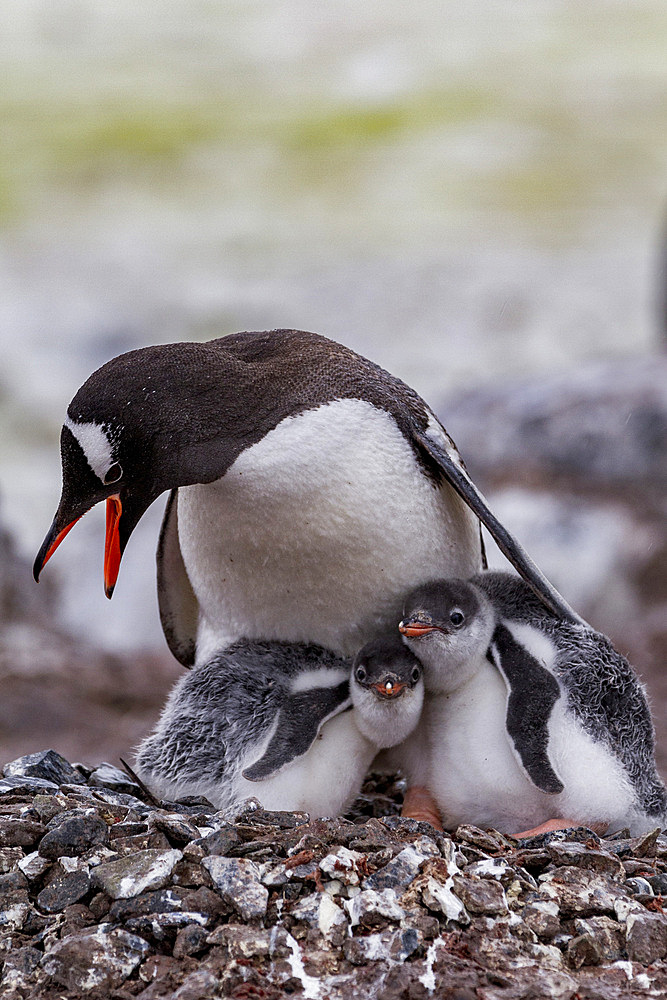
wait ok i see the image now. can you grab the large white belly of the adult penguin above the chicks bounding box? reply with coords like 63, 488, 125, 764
178, 399, 481, 663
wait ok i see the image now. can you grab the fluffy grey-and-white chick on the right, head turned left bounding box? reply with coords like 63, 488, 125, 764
399, 573, 667, 835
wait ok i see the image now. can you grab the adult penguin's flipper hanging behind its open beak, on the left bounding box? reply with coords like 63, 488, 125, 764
157, 490, 199, 667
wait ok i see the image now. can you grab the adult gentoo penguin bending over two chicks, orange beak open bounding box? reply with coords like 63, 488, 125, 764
34, 330, 576, 666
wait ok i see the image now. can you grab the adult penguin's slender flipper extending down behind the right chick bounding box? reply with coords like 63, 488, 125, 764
413, 428, 586, 625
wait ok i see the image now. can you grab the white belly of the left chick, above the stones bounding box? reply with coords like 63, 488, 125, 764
234, 711, 377, 816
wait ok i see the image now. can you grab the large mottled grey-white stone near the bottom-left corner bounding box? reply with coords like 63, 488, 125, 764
41, 924, 150, 993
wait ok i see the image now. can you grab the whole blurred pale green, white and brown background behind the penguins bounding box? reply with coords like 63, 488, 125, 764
0, 0, 667, 774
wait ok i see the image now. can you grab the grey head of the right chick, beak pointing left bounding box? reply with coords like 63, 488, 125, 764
398, 580, 495, 692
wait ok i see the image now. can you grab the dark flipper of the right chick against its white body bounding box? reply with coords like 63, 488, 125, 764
489, 624, 565, 795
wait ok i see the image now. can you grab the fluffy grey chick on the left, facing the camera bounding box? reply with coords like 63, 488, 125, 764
136, 640, 423, 816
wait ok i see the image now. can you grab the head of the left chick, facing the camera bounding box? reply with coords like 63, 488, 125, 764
350, 638, 424, 747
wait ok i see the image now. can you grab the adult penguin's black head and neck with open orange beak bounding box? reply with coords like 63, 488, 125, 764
33, 344, 262, 597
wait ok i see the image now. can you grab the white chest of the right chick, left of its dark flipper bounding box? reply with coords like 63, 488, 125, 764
424, 662, 545, 830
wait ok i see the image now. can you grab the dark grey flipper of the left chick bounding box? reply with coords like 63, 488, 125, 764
243, 681, 351, 781
